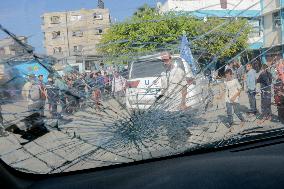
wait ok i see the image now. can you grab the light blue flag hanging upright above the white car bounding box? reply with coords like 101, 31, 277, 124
180, 35, 197, 75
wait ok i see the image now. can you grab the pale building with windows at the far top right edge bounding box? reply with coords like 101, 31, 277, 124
260, 0, 284, 57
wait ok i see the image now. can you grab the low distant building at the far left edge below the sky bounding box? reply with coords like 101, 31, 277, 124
0, 36, 32, 59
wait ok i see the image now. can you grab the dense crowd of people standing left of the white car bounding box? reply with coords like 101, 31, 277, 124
22, 64, 126, 118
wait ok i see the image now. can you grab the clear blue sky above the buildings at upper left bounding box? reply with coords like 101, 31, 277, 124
0, 0, 164, 53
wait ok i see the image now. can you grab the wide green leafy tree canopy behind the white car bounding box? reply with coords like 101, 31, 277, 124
99, 5, 250, 64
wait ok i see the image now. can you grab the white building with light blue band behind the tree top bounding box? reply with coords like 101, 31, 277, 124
157, 0, 263, 50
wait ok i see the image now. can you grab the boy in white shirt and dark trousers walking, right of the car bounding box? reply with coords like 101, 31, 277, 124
221, 69, 245, 126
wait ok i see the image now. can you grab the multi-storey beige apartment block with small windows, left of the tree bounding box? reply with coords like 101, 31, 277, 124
42, 8, 110, 72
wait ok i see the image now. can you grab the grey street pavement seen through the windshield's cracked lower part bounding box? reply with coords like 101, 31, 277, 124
0, 83, 283, 173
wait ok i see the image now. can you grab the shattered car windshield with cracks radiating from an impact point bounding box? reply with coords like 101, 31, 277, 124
0, 0, 284, 174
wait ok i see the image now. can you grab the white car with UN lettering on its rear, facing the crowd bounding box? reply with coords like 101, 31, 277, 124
126, 55, 210, 111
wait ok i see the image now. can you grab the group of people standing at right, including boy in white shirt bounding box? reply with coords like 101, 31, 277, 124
218, 59, 284, 126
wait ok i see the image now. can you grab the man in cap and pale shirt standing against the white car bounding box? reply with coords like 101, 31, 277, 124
161, 52, 188, 110
